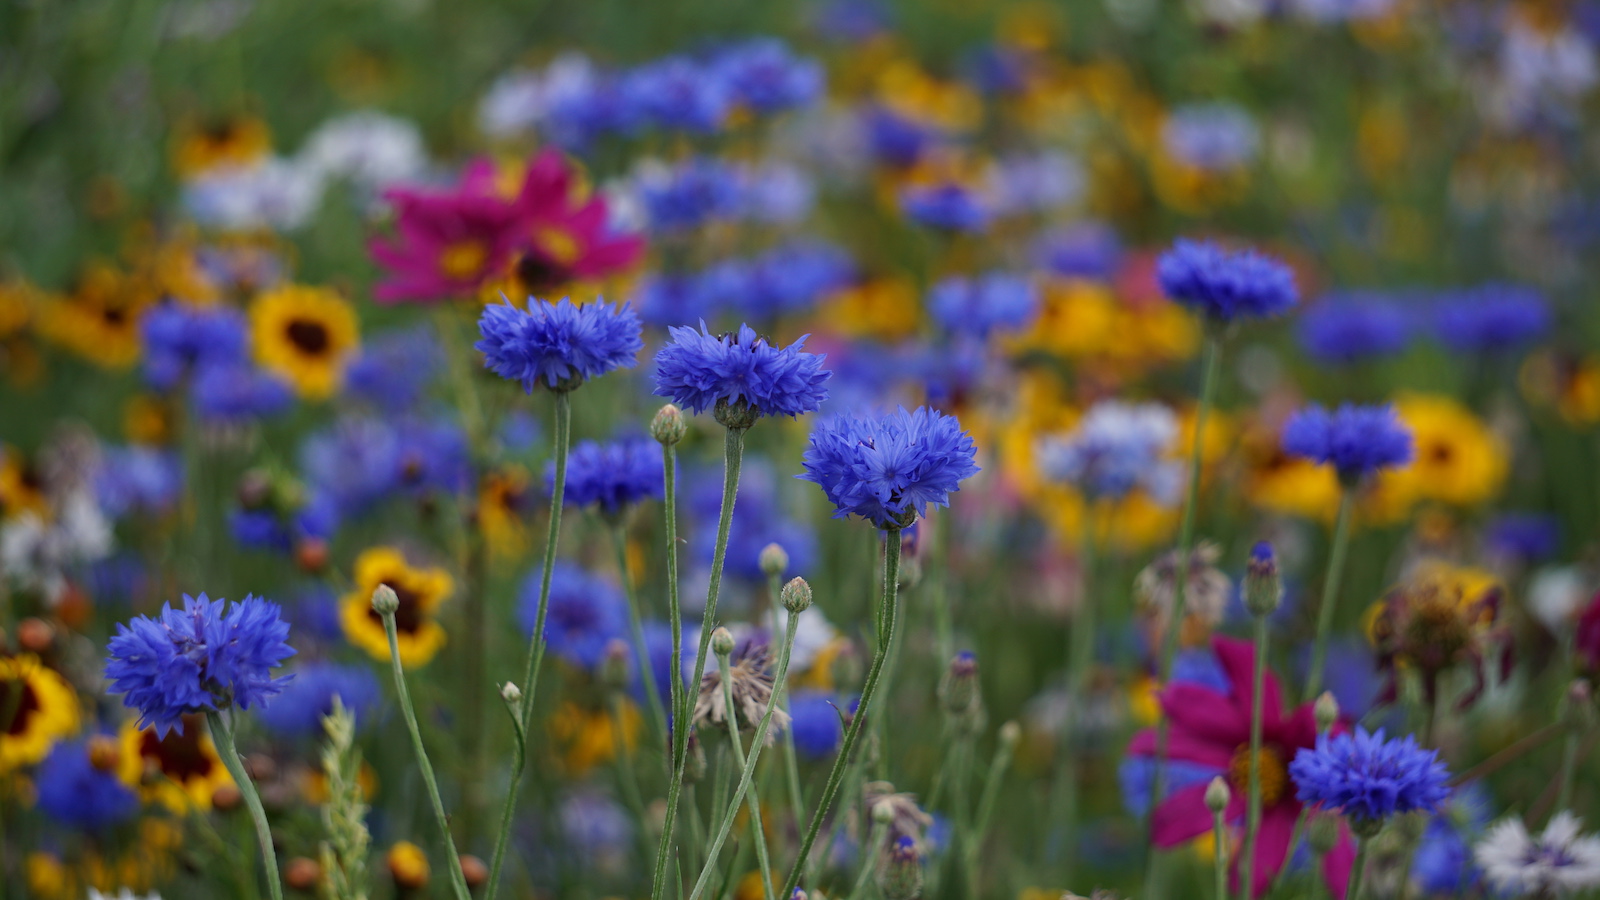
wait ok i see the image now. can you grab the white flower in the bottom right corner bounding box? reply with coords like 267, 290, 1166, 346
1474, 810, 1600, 897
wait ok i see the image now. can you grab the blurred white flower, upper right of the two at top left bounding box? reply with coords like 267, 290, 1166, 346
299, 110, 427, 189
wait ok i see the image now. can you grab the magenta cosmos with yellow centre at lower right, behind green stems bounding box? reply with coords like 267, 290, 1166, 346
1128, 637, 1355, 897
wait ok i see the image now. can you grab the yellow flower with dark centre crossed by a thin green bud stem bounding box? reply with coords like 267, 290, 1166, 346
339, 546, 456, 668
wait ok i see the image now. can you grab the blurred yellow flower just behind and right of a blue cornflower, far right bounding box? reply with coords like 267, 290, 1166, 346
1378, 394, 1510, 506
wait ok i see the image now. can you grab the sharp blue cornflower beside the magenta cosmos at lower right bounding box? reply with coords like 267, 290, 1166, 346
1290, 727, 1450, 823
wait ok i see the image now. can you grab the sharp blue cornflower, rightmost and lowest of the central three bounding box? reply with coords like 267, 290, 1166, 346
797, 407, 978, 528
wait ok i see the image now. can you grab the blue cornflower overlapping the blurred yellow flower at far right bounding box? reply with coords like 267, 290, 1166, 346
1283, 404, 1411, 484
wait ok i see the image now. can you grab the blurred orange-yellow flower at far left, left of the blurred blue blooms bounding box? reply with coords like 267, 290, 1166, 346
38, 263, 157, 370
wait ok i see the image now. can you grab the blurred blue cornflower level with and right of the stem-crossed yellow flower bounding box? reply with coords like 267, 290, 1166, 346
518, 560, 627, 671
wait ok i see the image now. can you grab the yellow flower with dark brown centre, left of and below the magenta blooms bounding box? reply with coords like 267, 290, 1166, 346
250, 285, 360, 400
